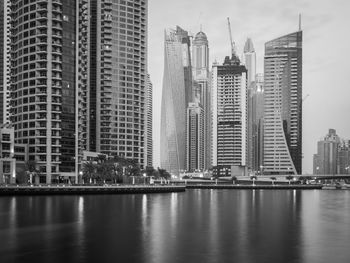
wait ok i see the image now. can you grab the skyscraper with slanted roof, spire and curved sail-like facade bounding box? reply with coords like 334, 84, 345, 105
263, 30, 302, 174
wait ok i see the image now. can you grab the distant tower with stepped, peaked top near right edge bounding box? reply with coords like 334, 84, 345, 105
314, 129, 340, 174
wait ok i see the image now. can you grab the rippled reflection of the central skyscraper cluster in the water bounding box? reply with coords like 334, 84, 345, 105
142, 190, 302, 262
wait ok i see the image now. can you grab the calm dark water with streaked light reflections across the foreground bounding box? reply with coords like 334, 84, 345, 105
0, 190, 350, 263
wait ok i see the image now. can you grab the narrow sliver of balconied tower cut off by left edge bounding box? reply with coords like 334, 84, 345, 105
0, 0, 11, 124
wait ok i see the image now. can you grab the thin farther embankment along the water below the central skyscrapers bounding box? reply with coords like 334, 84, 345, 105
186, 184, 322, 190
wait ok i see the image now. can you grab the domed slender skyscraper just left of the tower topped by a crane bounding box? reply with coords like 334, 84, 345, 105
192, 31, 211, 169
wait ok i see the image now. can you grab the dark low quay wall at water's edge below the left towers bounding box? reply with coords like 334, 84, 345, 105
0, 185, 186, 195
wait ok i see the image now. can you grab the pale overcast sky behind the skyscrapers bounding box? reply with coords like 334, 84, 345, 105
148, 0, 350, 173
